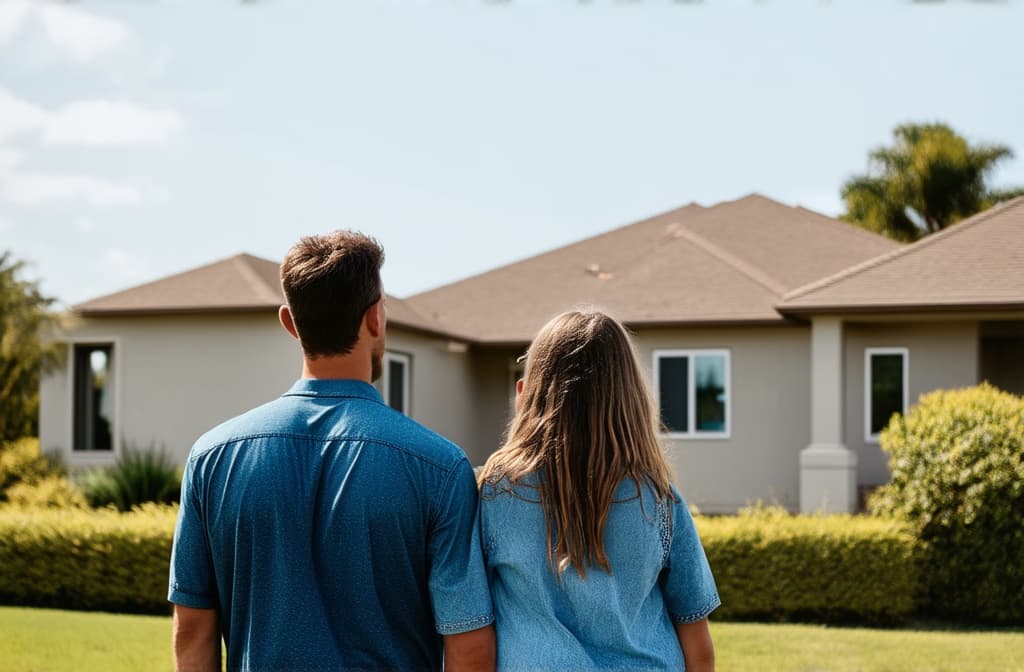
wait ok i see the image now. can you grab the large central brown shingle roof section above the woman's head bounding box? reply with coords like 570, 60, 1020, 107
409, 195, 897, 343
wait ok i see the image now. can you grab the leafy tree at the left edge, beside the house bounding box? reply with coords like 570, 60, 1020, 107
0, 252, 61, 444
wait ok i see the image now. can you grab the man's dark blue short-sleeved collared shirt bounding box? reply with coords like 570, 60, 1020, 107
168, 379, 494, 671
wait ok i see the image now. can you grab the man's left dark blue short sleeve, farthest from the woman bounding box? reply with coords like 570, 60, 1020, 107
167, 460, 217, 608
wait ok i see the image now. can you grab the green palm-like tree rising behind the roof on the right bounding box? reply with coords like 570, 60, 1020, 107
842, 124, 1024, 241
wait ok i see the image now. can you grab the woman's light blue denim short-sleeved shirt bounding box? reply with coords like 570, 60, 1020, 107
480, 474, 721, 670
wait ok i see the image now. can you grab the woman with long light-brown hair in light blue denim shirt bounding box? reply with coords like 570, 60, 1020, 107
479, 311, 721, 672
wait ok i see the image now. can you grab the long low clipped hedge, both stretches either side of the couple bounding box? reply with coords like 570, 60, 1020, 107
0, 504, 919, 623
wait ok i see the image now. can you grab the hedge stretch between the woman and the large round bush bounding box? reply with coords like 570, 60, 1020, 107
695, 509, 920, 625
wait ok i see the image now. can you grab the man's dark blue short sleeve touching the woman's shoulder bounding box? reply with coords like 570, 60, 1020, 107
429, 459, 495, 635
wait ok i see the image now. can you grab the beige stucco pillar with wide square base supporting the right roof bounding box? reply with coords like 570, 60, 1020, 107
800, 318, 857, 513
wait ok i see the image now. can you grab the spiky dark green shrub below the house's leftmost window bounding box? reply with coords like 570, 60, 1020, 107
79, 448, 181, 511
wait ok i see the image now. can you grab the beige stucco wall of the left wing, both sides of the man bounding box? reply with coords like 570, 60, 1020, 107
40, 312, 464, 467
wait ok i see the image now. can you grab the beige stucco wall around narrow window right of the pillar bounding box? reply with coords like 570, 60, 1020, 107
844, 321, 979, 486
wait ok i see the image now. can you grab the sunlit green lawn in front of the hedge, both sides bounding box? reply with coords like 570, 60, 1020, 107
0, 606, 1024, 672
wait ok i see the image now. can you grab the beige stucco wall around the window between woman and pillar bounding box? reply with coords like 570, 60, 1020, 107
637, 326, 811, 513
